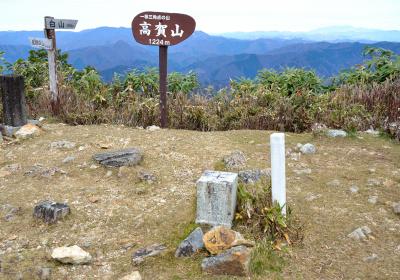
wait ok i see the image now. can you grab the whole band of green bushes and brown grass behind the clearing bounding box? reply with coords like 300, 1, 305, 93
0, 48, 400, 140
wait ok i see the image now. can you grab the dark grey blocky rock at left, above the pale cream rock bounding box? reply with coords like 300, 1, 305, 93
33, 200, 71, 224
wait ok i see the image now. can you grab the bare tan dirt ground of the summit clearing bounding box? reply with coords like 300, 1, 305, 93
0, 124, 400, 279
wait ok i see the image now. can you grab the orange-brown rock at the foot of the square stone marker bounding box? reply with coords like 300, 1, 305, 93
203, 226, 254, 255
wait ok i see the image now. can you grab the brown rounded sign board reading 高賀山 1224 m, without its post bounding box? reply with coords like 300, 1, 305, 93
132, 12, 196, 46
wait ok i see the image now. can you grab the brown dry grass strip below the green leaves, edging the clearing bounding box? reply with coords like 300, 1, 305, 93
18, 80, 400, 140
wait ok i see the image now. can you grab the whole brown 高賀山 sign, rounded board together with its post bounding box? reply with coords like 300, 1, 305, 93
132, 12, 196, 128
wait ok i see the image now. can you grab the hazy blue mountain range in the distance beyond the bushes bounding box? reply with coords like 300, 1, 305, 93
0, 27, 400, 86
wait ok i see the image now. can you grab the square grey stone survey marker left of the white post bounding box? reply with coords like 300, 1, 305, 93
196, 171, 238, 228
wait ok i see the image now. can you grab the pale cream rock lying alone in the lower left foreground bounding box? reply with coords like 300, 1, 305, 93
51, 245, 92, 264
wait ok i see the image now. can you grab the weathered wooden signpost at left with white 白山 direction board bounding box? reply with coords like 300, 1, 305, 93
42, 17, 78, 115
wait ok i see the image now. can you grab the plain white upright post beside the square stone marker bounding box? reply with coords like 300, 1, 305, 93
270, 133, 286, 216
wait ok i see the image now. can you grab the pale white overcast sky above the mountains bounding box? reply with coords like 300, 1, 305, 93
0, 0, 400, 34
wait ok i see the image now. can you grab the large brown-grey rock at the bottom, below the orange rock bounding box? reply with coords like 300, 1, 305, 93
201, 246, 251, 276
